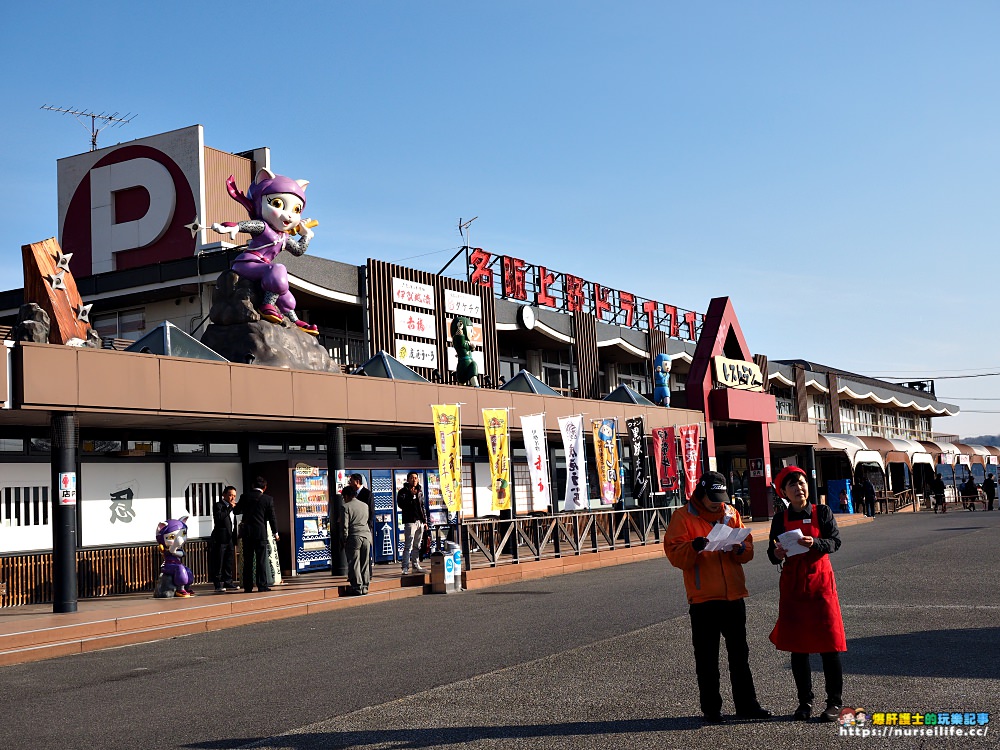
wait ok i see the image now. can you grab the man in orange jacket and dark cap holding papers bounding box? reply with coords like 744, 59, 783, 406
663, 471, 771, 724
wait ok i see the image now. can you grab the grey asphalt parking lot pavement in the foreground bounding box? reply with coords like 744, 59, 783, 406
0, 512, 1000, 750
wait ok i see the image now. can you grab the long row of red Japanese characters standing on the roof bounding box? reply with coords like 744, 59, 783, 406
469, 247, 704, 341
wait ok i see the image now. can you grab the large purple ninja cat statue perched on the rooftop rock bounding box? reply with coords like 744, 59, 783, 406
212, 169, 319, 336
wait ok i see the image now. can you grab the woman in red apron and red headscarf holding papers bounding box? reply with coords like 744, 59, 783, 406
767, 466, 847, 721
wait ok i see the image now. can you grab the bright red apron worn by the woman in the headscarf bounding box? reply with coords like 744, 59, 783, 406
771, 505, 847, 654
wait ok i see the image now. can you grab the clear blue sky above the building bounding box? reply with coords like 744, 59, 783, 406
0, 0, 1000, 436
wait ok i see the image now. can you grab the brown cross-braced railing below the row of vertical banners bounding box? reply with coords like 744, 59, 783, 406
461, 507, 672, 570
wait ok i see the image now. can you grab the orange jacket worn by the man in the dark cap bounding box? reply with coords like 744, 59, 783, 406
663, 503, 753, 604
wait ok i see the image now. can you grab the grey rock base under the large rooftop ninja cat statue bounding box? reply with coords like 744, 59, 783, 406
201, 271, 340, 372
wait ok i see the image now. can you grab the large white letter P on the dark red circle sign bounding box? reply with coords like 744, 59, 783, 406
90, 158, 177, 273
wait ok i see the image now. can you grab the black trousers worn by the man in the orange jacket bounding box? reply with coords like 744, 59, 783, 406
690, 599, 760, 715
